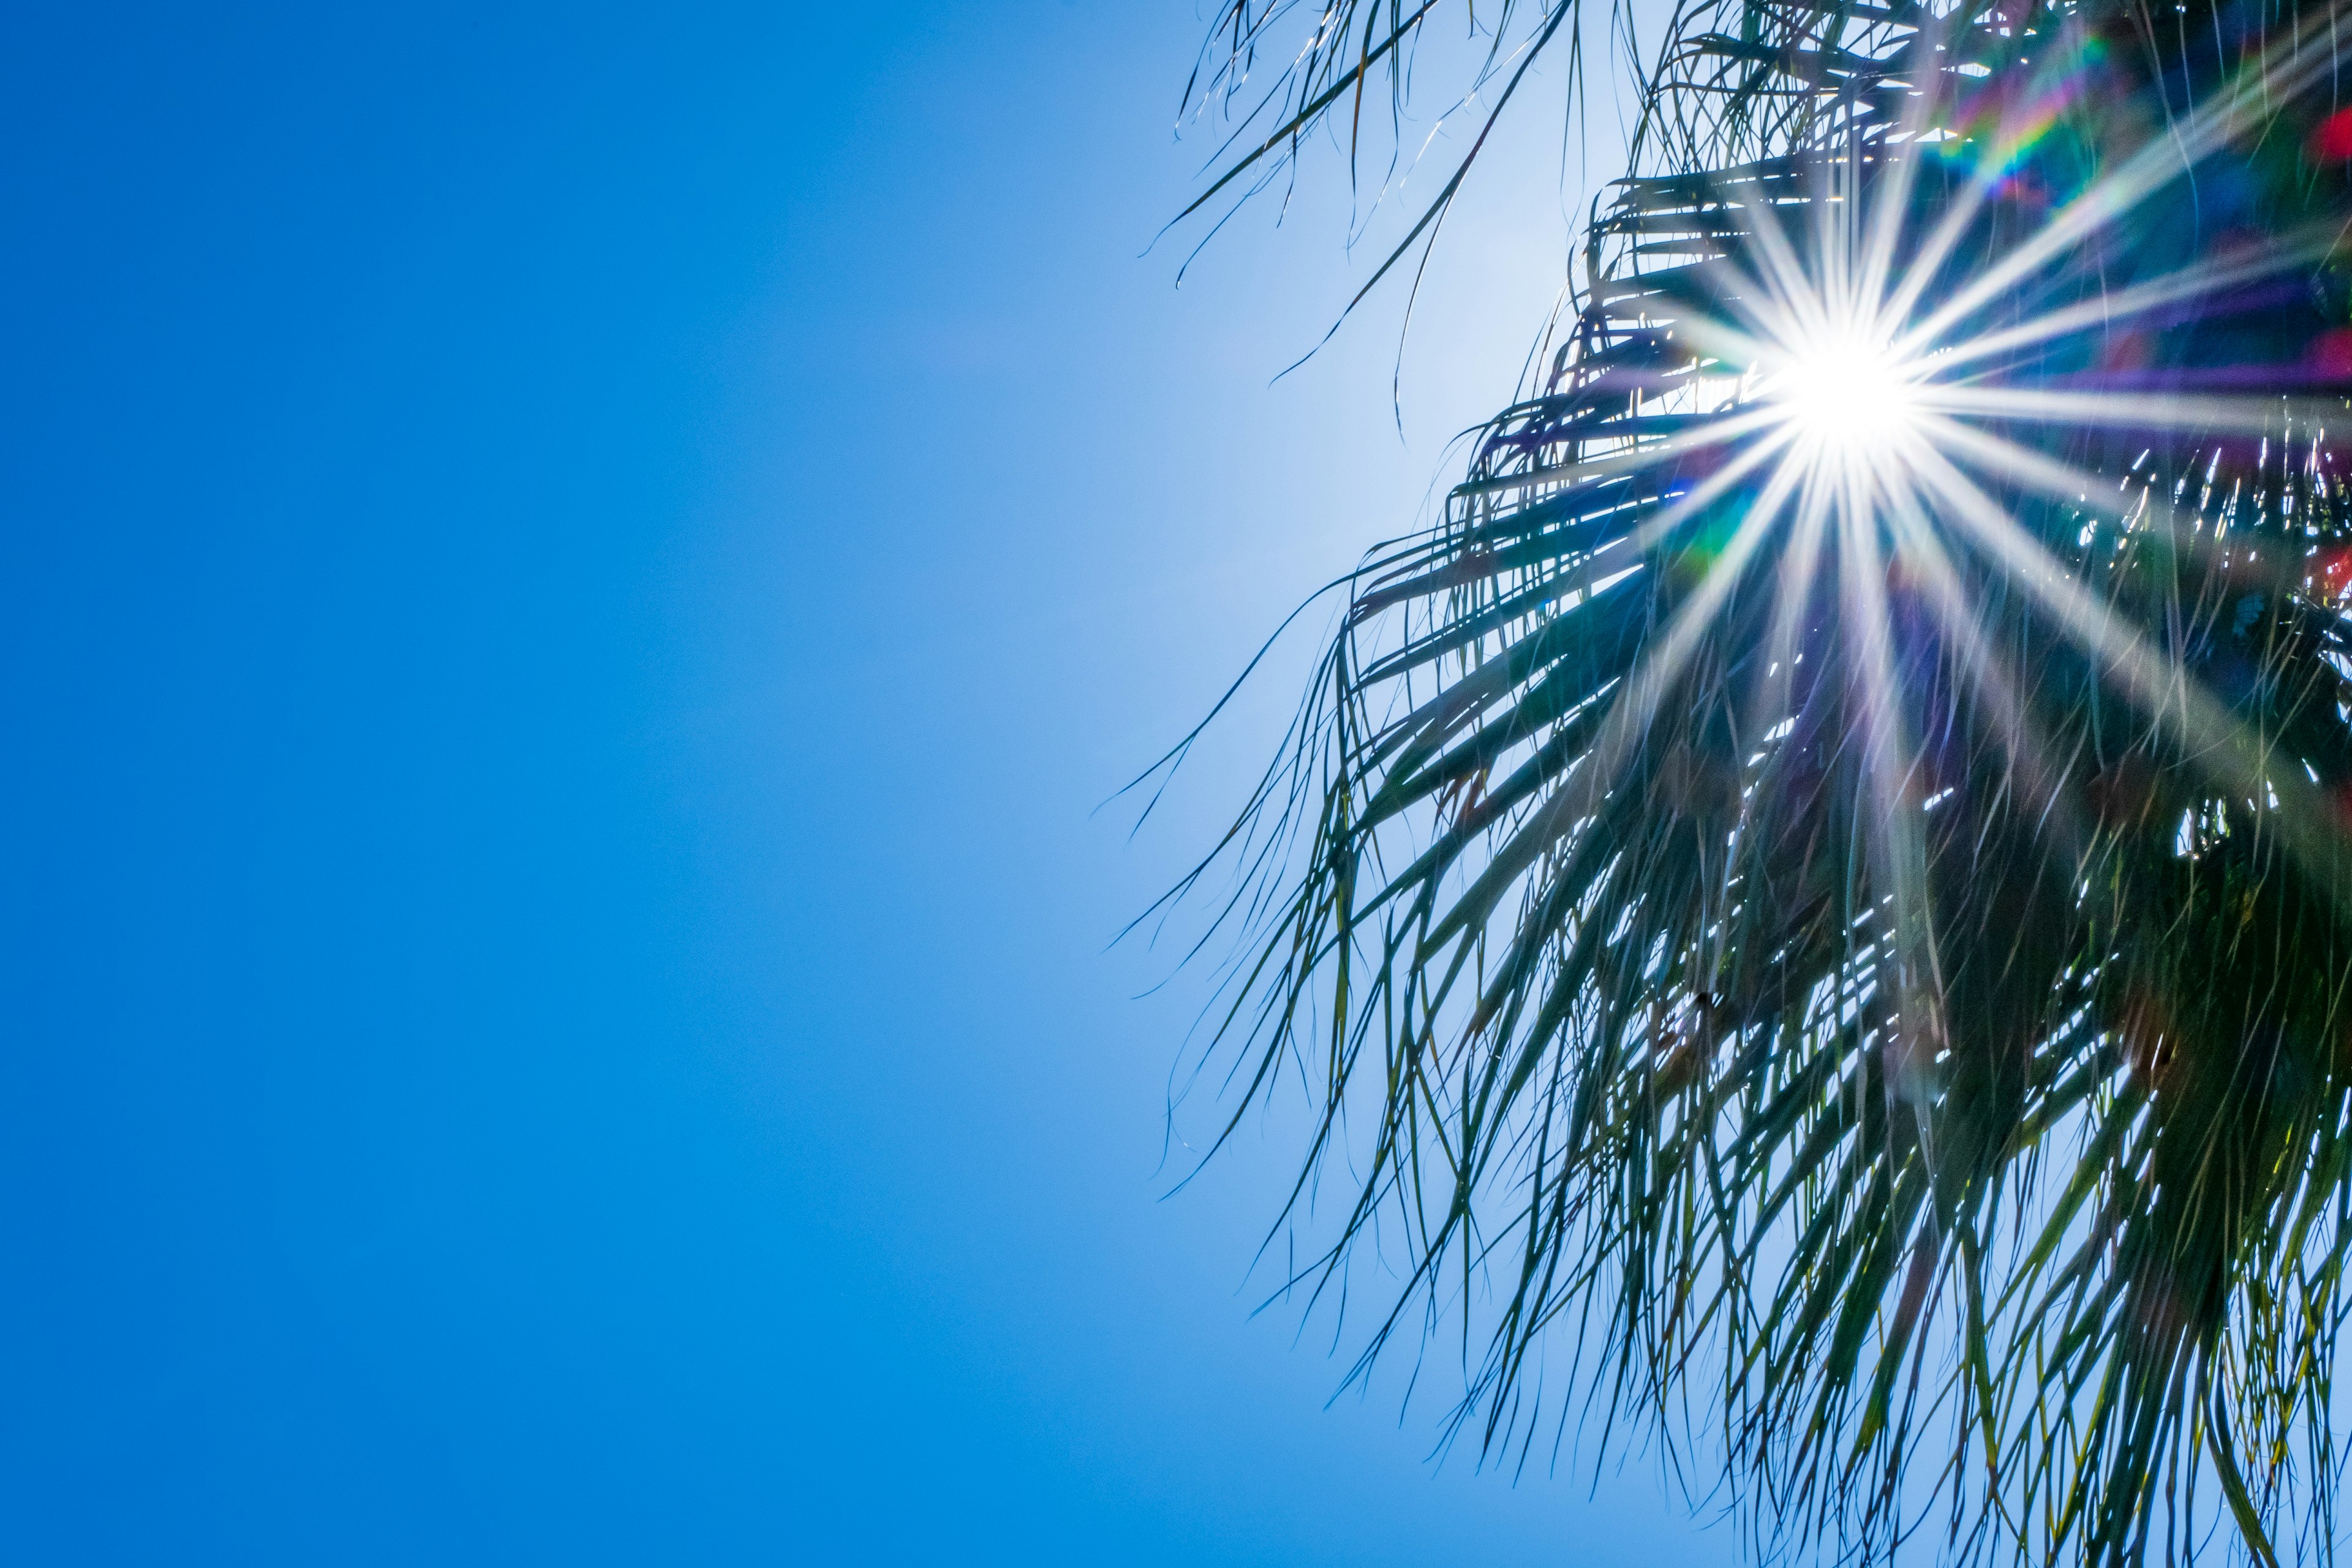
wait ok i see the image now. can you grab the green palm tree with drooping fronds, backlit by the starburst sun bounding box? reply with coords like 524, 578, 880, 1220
1193, 0, 2352, 1563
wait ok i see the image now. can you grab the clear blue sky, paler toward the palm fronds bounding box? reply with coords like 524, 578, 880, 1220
0, 0, 1733, 1568
